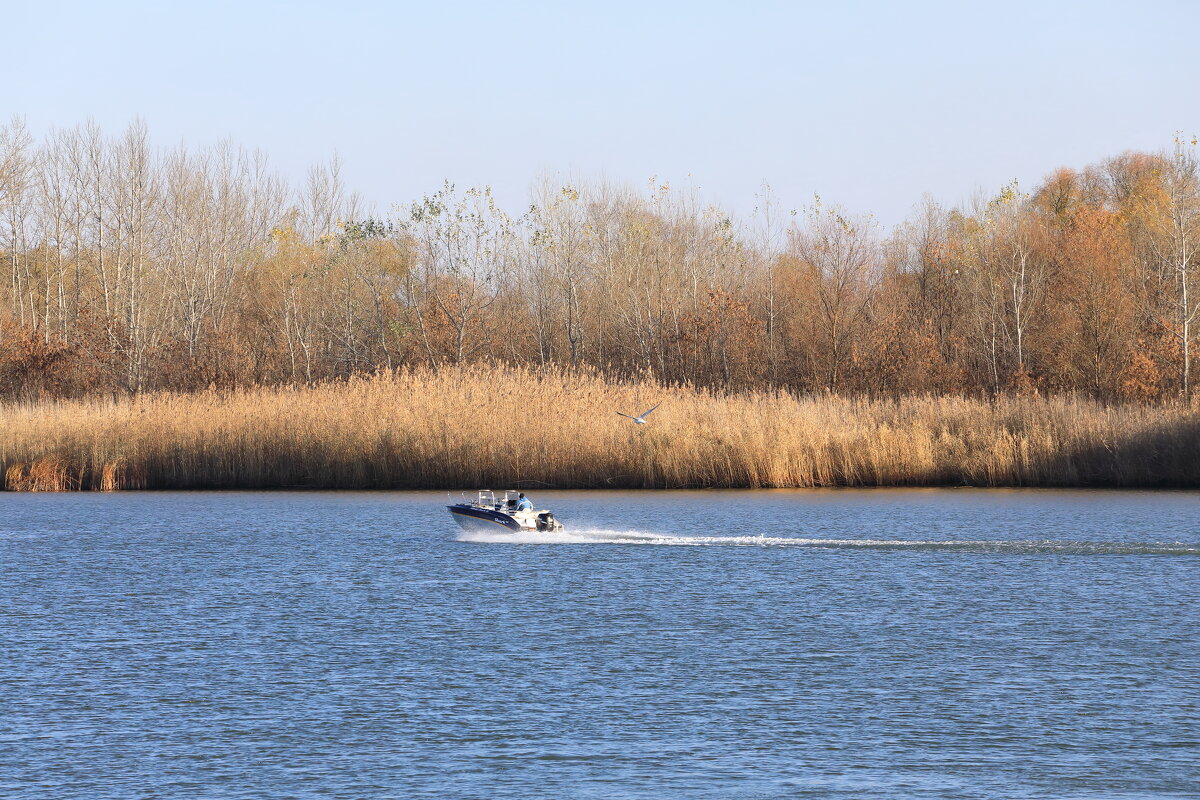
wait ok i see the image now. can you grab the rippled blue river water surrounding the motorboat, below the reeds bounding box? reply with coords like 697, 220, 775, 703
0, 489, 1200, 799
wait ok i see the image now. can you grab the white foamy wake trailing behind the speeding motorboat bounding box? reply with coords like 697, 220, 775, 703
457, 529, 1200, 555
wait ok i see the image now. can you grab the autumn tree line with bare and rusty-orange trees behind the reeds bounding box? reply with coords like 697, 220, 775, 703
0, 120, 1200, 401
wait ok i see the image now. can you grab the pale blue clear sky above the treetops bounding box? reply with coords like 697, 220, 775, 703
0, 0, 1200, 228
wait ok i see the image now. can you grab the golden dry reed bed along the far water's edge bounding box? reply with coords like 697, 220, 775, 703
0, 366, 1200, 492
